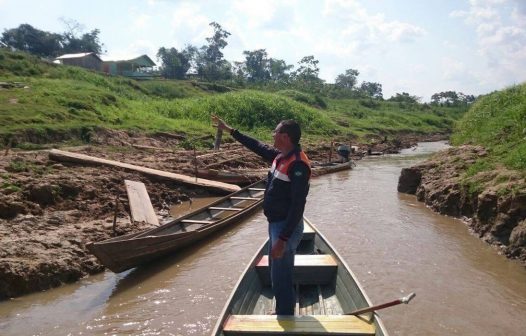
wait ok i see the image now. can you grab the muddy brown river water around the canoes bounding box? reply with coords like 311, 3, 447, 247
0, 143, 526, 336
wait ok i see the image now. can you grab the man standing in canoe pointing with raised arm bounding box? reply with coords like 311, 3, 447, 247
212, 116, 311, 315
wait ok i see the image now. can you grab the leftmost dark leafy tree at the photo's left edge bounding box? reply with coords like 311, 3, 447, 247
1, 24, 63, 57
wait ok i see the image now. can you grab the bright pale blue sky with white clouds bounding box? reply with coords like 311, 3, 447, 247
0, 0, 526, 101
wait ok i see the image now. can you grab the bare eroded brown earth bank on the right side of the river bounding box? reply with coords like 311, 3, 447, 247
398, 145, 526, 265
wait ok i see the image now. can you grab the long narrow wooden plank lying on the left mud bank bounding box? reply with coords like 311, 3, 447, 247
49, 149, 241, 192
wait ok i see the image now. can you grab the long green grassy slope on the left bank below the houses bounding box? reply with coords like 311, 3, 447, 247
0, 49, 468, 146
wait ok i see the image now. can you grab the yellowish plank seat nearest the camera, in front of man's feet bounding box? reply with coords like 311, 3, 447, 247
223, 315, 376, 336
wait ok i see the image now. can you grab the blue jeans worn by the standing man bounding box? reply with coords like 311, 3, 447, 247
268, 218, 303, 315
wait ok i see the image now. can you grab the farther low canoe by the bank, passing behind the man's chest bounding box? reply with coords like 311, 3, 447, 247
194, 161, 355, 185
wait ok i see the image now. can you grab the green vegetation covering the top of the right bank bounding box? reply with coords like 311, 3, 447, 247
451, 83, 526, 194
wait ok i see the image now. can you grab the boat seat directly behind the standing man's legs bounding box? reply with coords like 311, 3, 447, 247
256, 254, 338, 285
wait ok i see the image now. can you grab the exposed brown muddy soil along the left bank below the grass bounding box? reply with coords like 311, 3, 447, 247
0, 130, 438, 300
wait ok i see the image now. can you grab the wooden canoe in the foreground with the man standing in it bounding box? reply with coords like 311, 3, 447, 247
212, 219, 387, 336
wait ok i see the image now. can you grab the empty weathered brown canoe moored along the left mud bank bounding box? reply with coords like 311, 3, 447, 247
86, 180, 265, 273
